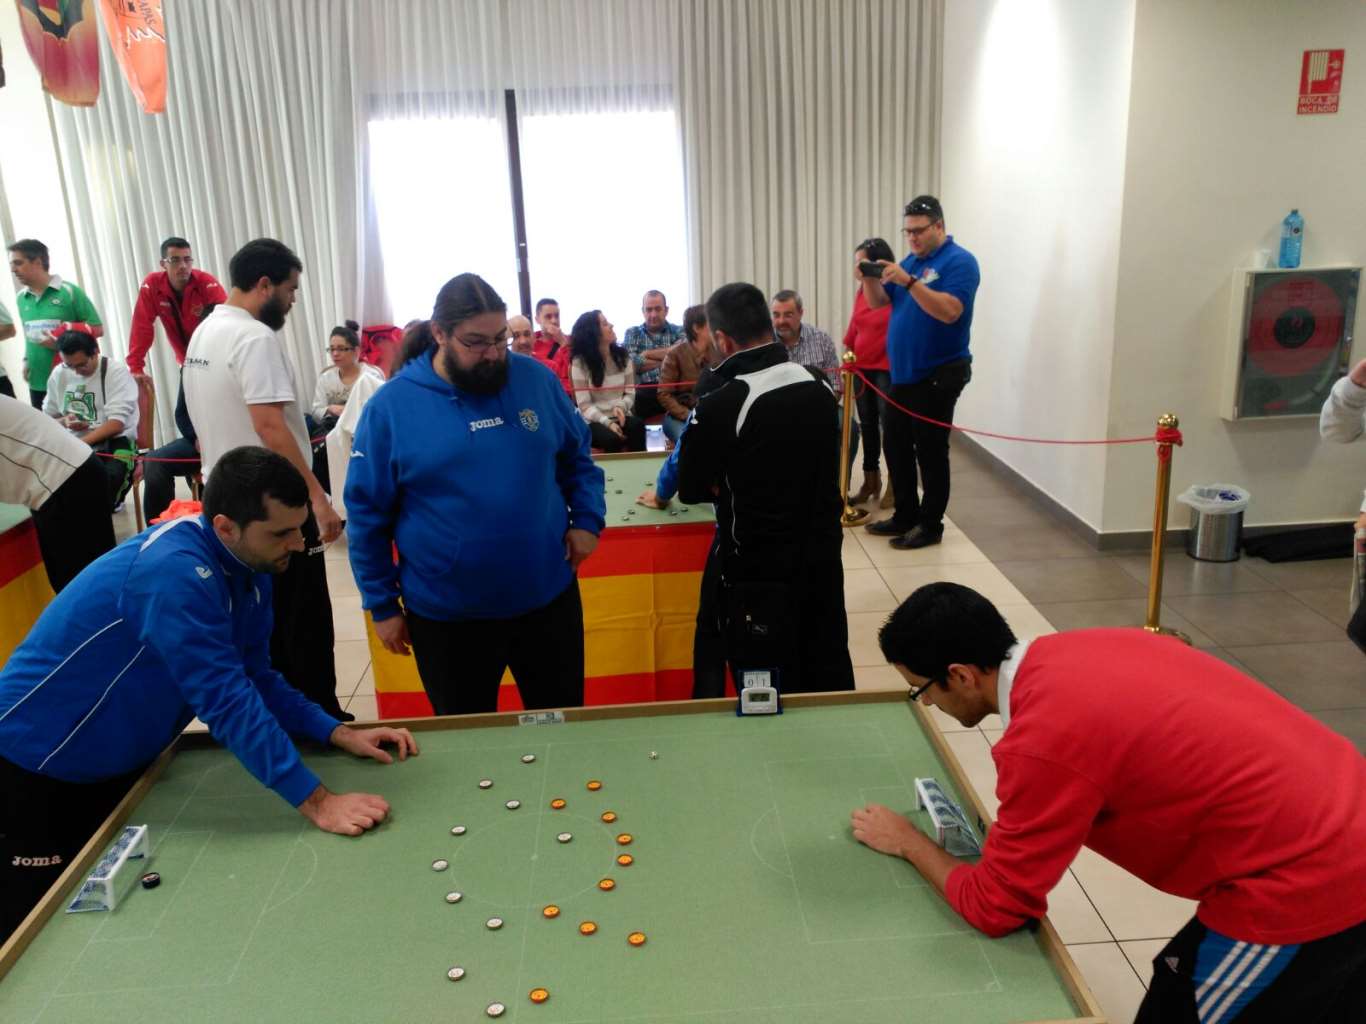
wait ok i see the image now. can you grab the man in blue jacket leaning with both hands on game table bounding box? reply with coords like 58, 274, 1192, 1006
0, 448, 417, 942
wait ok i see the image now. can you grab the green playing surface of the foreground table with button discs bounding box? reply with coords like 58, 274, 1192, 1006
0, 702, 1078, 1024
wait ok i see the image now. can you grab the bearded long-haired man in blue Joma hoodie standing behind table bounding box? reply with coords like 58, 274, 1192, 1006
346, 273, 607, 714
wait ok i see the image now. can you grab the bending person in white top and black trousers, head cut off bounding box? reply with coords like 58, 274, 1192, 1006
0, 395, 113, 593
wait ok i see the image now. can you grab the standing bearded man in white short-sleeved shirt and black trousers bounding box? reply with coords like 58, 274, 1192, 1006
180, 238, 352, 721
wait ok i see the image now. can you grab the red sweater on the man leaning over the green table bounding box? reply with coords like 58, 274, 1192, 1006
947, 629, 1366, 945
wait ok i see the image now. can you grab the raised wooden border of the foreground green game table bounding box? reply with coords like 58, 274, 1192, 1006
0, 690, 1106, 1024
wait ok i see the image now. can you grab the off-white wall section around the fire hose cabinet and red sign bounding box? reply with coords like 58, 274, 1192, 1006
1104, 0, 1366, 531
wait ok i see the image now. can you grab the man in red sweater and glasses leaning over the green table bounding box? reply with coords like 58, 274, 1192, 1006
852, 583, 1366, 1024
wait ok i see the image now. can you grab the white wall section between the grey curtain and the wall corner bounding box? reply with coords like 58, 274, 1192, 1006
941, 0, 1153, 528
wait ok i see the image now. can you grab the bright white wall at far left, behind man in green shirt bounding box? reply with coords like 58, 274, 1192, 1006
0, 3, 78, 385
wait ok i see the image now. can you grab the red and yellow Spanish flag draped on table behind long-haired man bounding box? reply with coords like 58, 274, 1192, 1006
366, 522, 716, 718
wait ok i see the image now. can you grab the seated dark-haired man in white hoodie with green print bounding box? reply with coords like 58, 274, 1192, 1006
42, 324, 138, 511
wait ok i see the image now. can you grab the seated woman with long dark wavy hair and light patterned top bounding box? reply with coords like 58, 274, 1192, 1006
570, 310, 645, 452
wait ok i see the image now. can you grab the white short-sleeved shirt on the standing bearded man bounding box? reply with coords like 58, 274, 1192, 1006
182, 304, 313, 477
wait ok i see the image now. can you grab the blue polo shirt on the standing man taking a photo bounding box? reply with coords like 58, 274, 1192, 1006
887, 235, 982, 384
